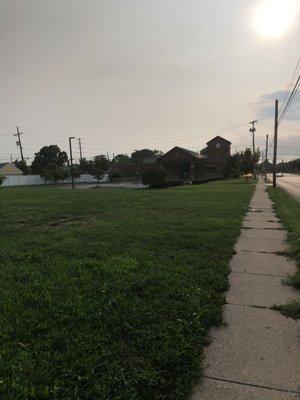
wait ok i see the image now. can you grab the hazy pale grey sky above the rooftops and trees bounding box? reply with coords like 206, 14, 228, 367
0, 0, 300, 163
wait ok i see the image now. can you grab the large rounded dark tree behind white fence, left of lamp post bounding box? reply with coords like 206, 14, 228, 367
31, 144, 68, 174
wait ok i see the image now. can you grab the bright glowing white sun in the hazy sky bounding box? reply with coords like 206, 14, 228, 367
254, 0, 299, 39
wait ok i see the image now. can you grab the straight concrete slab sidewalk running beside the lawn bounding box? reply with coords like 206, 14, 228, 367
192, 179, 300, 400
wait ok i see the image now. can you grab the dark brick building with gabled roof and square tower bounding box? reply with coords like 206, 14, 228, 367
158, 136, 231, 180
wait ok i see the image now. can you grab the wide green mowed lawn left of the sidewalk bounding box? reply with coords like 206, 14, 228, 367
0, 180, 254, 400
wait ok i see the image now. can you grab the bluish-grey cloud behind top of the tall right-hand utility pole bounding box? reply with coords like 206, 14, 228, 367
255, 90, 300, 121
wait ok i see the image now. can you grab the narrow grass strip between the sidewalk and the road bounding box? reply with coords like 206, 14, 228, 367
268, 186, 300, 319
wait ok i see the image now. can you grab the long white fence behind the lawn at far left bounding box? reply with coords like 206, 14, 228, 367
1, 174, 108, 186
